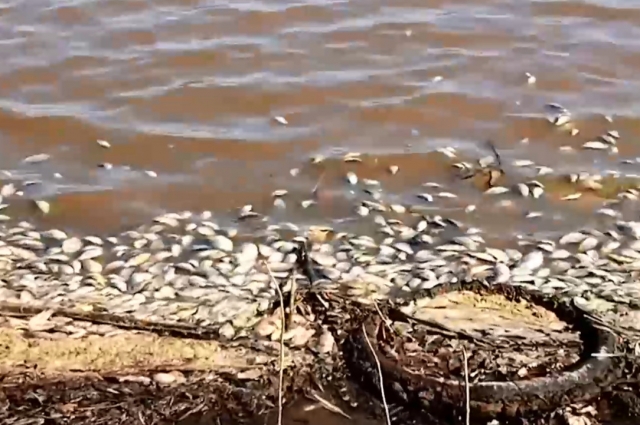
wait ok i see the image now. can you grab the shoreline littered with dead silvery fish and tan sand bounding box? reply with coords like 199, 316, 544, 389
0, 171, 640, 423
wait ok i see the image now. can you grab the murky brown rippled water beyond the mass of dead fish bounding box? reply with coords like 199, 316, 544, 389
0, 0, 640, 236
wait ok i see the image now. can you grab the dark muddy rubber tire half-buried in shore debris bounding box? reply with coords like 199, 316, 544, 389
344, 284, 616, 424
